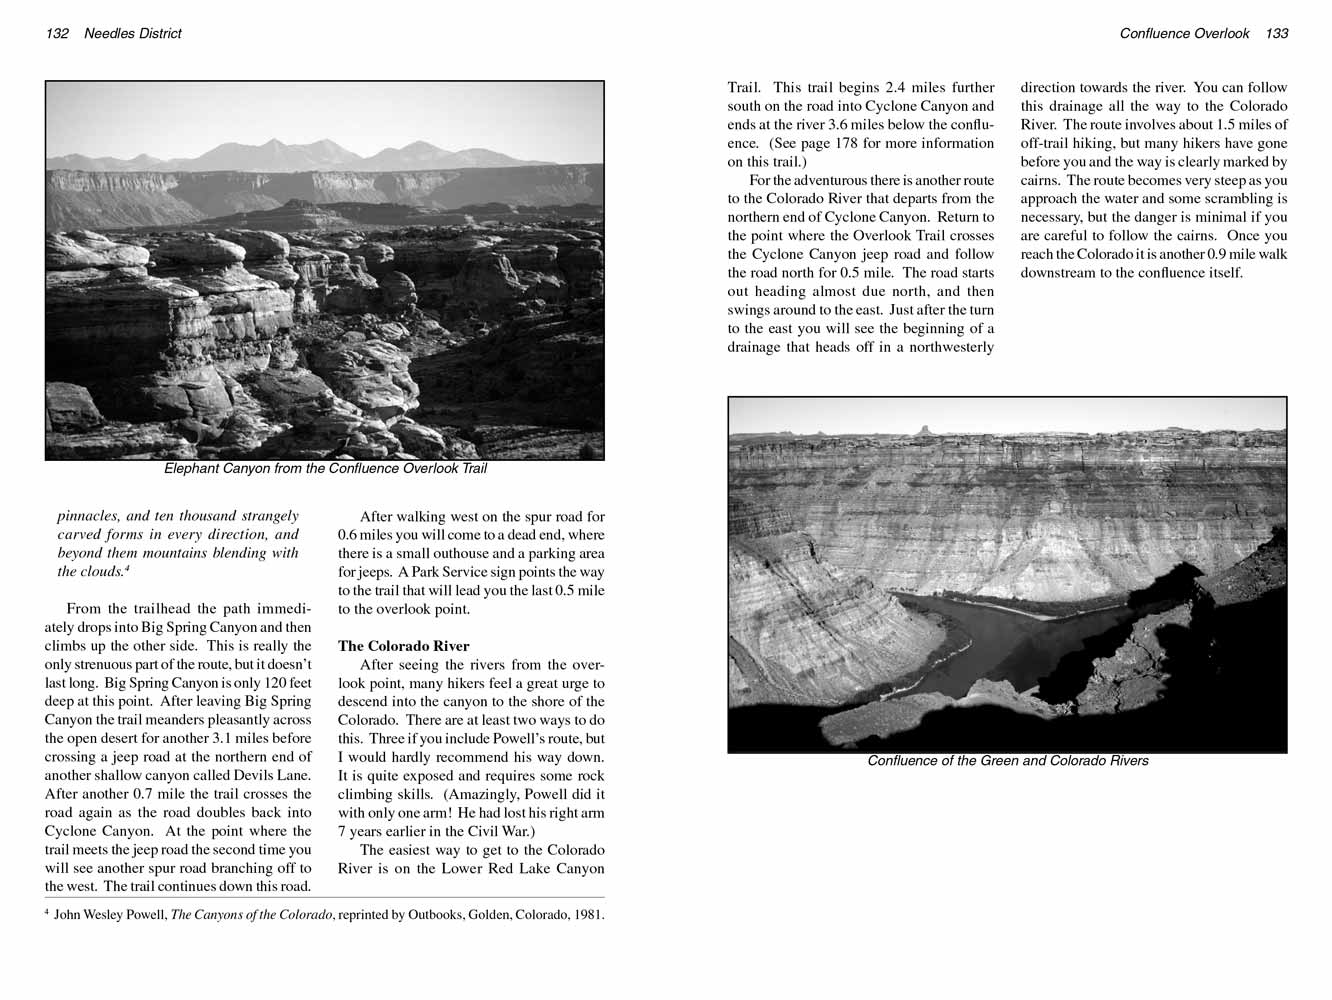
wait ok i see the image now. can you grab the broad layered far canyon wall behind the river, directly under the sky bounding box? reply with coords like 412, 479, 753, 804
730, 429, 1285, 601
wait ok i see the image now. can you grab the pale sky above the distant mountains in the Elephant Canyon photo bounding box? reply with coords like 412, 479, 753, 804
47, 81, 603, 169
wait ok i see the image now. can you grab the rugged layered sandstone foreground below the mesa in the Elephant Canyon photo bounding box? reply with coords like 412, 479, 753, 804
45, 218, 605, 459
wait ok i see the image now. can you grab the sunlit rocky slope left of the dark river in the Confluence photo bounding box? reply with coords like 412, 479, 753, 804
729, 498, 944, 706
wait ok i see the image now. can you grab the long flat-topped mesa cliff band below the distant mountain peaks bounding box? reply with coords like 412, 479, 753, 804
47, 164, 605, 232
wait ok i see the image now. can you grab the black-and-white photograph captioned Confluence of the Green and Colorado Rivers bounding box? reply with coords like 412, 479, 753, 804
727, 397, 1287, 754
